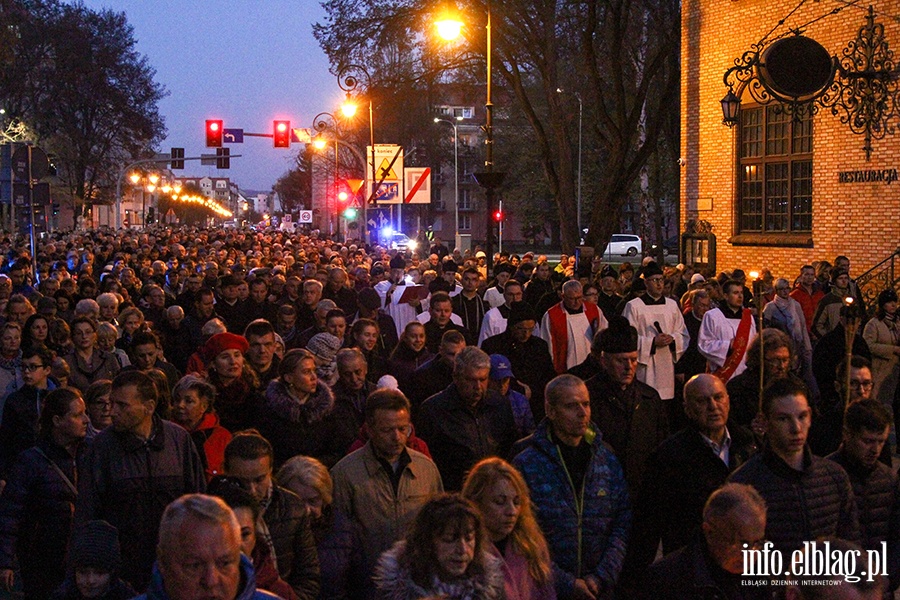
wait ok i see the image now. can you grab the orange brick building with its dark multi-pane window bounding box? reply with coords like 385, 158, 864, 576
680, 0, 900, 279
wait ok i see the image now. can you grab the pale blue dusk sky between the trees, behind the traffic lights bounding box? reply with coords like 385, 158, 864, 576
78, 0, 342, 192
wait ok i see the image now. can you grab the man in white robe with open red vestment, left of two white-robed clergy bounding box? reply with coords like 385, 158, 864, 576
536, 279, 607, 373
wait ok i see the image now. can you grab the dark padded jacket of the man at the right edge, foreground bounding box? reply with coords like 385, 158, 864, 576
827, 447, 900, 590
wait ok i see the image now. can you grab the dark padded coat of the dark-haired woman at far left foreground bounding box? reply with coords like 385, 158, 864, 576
0, 440, 78, 598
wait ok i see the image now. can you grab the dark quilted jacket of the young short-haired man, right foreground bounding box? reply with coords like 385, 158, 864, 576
728, 447, 860, 552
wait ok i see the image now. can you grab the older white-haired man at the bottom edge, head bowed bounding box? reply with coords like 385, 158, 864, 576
138, 494, 278, 600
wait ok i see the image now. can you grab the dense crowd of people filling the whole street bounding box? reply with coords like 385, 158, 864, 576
0, 228, 900, 600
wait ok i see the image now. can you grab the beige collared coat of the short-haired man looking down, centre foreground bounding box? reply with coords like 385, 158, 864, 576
331, 441, 444, 575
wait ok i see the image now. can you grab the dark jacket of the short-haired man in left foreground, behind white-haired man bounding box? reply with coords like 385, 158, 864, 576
75, 416, 206, 589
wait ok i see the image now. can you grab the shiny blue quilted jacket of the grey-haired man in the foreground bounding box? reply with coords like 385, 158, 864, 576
513, 419, 631, 598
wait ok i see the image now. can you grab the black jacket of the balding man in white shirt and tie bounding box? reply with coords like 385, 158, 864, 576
626, 423, 757, 571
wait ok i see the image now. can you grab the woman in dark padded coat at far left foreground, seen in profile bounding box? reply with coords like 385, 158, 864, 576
0, 388, 88, 599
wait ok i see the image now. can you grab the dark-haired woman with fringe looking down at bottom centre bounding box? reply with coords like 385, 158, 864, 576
373, 494, 504, 600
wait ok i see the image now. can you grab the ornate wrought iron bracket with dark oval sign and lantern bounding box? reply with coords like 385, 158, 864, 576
721, 6, 900, 161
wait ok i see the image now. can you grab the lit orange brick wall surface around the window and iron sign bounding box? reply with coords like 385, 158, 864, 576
681, 0, 900, 278
